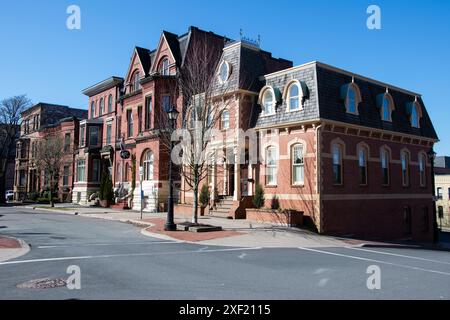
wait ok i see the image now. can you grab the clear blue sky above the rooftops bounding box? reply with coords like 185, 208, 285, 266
0, 0, 450, 155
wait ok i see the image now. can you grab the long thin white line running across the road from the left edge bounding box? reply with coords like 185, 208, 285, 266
0, 247, 262, 266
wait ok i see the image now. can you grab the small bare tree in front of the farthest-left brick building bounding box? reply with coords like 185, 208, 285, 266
34, 133, 71, 207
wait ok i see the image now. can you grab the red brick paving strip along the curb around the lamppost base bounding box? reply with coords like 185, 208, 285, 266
142, 219, 246, 243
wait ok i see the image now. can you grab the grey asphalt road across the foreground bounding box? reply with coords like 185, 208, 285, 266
0, 207, 450, 300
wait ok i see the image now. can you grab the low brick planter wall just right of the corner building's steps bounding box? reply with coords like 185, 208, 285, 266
246, 209, 303, 227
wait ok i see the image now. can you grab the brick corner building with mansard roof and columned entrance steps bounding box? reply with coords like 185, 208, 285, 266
178, 41, 438, 241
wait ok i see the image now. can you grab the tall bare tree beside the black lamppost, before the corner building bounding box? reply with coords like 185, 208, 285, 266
158, 36, 231, 224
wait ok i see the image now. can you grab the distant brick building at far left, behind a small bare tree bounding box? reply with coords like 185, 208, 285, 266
14, 103, 87, 201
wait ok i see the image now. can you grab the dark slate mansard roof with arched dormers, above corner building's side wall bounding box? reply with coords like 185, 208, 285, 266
256, 62, 438, 140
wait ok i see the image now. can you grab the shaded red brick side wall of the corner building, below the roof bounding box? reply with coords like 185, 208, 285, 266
322, 132, 433, 241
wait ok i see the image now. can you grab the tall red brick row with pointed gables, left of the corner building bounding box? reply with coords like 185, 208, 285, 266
73, 27, 230, 212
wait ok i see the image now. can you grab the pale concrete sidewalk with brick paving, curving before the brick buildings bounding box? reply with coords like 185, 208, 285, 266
22, 205, 348, 248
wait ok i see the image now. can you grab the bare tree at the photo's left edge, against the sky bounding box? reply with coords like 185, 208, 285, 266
0, 95, 31, 203
